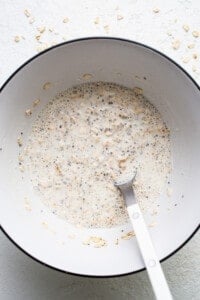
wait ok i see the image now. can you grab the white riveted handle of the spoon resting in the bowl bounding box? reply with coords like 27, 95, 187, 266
127, 203, 173, 300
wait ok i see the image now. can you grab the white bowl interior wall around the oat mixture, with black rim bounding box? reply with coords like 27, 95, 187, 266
0, 38, 200, 276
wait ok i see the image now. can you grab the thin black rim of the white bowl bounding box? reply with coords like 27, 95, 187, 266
0, 36, 200, 278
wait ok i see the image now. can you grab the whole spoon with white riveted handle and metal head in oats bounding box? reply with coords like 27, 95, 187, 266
115, 174, 172, 300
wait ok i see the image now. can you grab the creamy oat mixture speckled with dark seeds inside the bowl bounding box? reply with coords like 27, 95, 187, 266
20, 82, 171, 228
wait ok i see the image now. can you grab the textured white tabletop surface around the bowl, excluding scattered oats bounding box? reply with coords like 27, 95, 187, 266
0, 0, 200, 300
